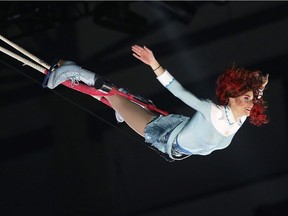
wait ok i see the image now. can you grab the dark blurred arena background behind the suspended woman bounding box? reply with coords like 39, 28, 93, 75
0, 1, 288, 216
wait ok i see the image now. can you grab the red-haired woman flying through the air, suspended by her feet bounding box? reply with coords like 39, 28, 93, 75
48, 45, 269, 161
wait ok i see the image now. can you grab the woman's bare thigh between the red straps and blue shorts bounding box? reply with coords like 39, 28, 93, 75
106, 95, 155, 137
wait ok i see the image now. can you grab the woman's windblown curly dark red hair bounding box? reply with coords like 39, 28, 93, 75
216, 66, 268, 126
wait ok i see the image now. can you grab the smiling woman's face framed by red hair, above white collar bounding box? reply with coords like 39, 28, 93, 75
229, 91, 254, 120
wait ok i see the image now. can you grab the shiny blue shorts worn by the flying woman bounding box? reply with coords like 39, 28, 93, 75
144, 114, 190, 157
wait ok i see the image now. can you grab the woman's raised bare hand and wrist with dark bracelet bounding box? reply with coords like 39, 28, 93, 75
132, 45, 165, 77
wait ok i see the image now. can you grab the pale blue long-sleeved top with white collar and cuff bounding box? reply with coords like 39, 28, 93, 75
157, 70, 247, 155
